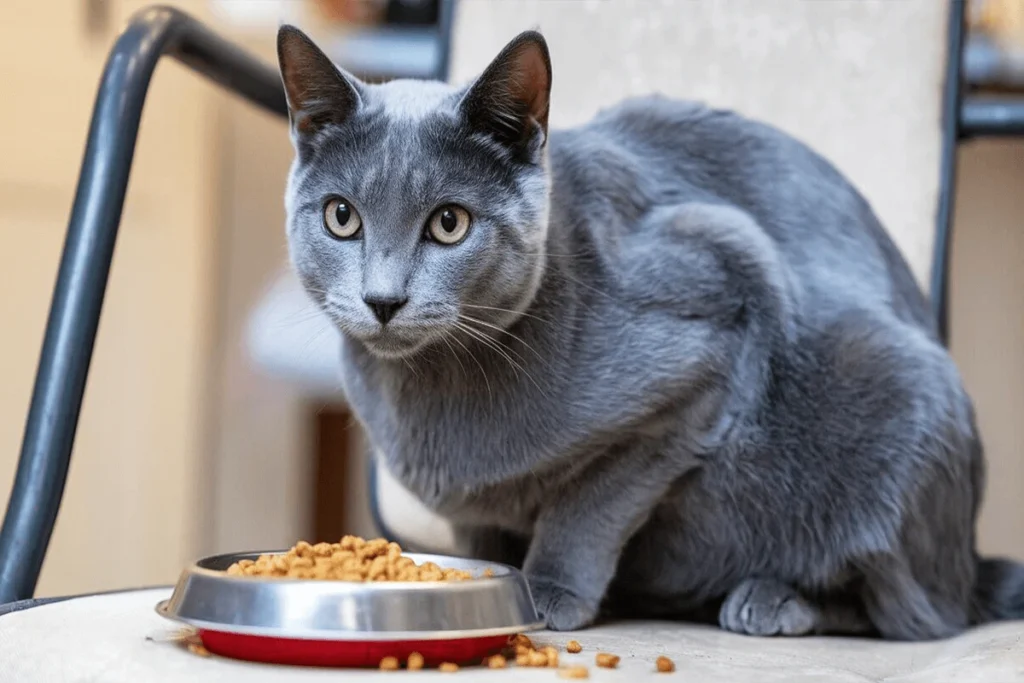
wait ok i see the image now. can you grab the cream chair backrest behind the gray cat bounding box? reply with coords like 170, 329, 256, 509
377, 0, 949, 546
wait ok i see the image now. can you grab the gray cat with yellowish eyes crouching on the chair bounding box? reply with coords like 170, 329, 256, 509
279, 27, 1024, 640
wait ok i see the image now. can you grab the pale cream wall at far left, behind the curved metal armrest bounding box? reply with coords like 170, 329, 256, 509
0, 0, 224, 595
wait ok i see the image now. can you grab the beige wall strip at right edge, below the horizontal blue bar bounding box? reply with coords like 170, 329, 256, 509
950, 140, 1024, 559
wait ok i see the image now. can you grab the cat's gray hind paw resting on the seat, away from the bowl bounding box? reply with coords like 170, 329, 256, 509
718, 579, 818, 636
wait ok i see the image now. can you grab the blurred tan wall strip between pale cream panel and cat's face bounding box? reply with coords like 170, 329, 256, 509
203, 87, 307, 552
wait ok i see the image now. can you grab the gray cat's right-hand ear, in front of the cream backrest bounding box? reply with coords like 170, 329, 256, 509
460, 31, 551, 156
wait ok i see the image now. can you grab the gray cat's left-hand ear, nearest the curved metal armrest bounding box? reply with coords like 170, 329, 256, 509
278, 26, 359, 135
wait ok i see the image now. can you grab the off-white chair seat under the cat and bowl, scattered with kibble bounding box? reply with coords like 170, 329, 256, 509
0, 589, 1024, 683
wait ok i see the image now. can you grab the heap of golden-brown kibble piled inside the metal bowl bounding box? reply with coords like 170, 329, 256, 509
227, 536, 471, 582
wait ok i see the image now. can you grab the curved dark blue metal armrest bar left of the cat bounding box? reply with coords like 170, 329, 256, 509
0, 7, 287, 604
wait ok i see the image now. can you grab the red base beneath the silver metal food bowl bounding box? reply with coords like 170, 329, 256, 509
199, 630, 508, 669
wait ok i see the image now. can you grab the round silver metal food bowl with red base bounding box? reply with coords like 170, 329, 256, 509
157, 551, 543, 667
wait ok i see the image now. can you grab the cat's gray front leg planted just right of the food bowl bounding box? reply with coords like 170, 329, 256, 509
523, 447, 696, 631
